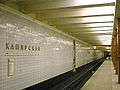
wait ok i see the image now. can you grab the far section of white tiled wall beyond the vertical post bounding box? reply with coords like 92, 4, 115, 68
76, 42, 102, 67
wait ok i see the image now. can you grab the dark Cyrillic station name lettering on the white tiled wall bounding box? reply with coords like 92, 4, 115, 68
6, 43, 40, 51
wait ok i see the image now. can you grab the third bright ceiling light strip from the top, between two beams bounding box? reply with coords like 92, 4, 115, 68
53, 15, 114, 25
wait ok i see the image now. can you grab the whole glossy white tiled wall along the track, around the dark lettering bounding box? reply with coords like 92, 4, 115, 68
0, 6, 102, 90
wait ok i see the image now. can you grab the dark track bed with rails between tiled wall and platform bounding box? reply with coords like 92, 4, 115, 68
23, 56, 106, 90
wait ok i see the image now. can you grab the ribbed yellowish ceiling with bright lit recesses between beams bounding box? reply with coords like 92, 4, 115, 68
0, 0, 120, 46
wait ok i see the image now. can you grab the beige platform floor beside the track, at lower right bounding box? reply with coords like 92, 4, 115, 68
80, 60, 120, 90
